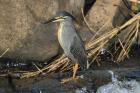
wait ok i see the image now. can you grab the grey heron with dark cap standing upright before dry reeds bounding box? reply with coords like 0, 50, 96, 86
45, 11, 88, 79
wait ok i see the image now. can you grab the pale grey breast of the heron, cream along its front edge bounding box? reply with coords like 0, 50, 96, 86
58, 20, 75, 53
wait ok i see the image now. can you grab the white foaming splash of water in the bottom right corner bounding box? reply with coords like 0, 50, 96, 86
96, 71, 140, 93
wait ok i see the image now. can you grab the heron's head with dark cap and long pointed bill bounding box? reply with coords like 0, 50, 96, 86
44, 11, 75, 24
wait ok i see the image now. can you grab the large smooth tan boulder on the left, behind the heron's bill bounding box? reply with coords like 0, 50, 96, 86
0, 0, 84, 61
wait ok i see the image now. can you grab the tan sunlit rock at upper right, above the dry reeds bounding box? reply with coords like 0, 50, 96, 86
86, 0, 129, 32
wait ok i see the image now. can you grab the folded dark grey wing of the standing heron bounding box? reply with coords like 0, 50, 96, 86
70, 35, 87, 69
